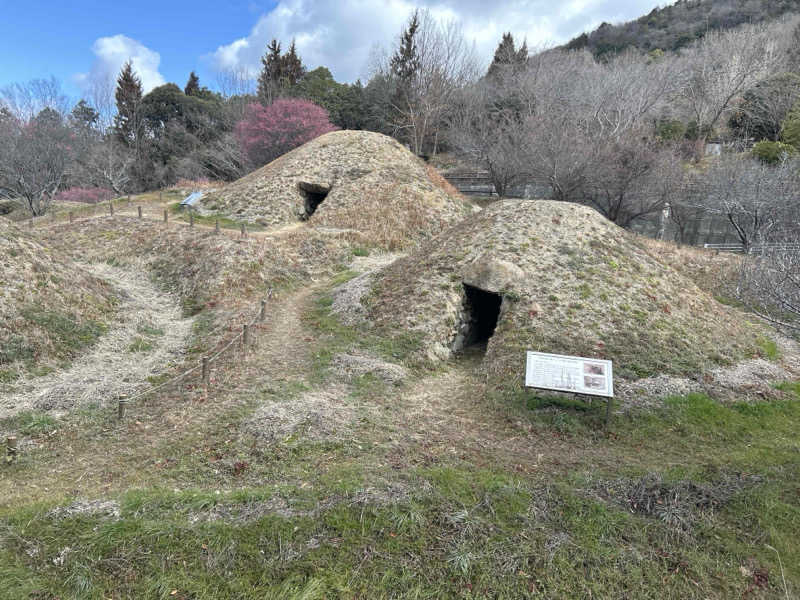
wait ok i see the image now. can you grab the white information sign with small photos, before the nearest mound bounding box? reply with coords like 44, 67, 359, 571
525, 352, 614, 398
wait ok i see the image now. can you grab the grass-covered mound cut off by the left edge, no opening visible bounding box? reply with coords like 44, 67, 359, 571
0, 219, 114, 384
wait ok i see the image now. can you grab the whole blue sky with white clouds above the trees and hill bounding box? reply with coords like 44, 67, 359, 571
0, 0, 658, 102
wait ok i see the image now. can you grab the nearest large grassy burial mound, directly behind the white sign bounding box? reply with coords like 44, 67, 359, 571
334, 200, 763, 386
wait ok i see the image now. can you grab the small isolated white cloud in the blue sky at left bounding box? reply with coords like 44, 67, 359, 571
76, 34, 166, 93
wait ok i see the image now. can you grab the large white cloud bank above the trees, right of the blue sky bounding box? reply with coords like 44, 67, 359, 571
211, 0, 658, 81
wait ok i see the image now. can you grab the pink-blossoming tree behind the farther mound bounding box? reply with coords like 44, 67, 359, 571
236, 98, 338, 167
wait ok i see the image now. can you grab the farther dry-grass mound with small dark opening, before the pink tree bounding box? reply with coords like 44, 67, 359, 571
203, 131, 472, 248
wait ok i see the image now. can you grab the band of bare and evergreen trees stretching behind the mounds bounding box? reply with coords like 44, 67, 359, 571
0, 4, 800, 237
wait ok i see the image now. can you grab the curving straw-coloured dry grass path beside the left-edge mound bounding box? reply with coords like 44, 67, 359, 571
0, 263, 192, 418
